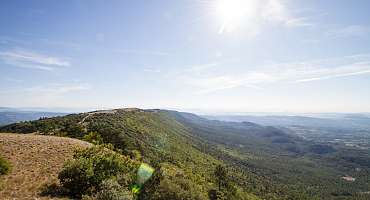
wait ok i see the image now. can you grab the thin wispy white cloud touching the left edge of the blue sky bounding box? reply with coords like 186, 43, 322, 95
0, 50, 70, 71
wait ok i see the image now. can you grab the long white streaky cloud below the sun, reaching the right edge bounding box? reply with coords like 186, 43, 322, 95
181, 54, 370, 94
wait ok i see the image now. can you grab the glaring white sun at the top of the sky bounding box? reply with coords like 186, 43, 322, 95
213, 0, 256, 33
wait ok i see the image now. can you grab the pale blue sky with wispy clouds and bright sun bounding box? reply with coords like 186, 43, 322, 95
0, 0, 370, 112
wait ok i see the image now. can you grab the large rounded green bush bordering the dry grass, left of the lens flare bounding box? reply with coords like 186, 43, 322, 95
58, 146, 137, 197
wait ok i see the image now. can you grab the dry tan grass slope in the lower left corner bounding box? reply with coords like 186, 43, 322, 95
0, 133, 90, 200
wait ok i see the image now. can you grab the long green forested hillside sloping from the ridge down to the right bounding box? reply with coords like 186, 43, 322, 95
0, 109, 370, 200
